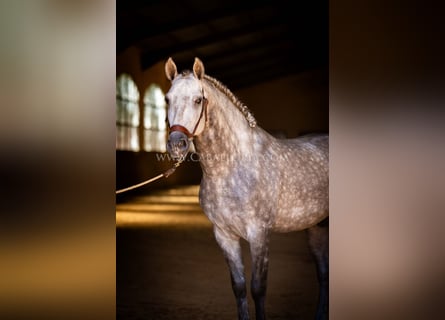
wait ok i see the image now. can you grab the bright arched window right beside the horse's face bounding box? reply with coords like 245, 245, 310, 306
144, 84, 167, 152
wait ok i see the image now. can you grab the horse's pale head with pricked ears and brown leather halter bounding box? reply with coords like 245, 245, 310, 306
165, 58, 208, 159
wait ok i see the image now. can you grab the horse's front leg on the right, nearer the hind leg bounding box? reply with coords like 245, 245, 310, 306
249, 233, 269, 320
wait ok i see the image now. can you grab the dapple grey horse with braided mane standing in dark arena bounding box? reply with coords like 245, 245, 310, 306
165, 58, 329, 320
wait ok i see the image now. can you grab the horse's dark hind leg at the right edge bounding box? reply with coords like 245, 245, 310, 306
307, 218, 329, 320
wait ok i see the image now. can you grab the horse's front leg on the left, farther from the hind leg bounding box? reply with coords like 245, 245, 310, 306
214, 227, 249, 320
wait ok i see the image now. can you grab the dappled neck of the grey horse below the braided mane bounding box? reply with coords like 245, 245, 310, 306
195, 87, 256, 174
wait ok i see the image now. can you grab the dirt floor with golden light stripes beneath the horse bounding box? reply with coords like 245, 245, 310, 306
116, 187, 318, 320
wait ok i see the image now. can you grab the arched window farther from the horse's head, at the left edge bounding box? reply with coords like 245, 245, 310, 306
116, 73, 139, 151
